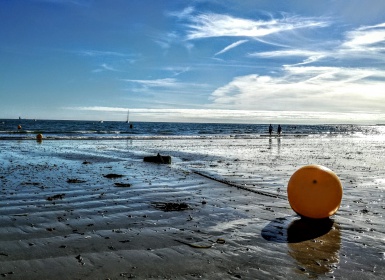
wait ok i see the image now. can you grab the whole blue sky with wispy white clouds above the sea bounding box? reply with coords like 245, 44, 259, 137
0, 0, 385, 124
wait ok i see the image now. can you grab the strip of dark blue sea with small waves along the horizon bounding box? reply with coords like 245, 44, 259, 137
0, 119, 385, 140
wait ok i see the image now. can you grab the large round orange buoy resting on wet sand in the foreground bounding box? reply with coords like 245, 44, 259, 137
287, 164, 342, 219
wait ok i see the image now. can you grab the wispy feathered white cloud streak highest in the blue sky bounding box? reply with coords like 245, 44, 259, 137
183, 13, 328, 40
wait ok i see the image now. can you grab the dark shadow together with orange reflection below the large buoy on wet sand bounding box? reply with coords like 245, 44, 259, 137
262, 217, 341, 277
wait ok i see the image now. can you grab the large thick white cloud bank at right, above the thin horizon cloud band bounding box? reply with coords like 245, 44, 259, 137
211, 66, 385, 112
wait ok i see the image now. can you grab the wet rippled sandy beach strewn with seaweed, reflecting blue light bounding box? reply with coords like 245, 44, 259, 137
0, 137, 385, 279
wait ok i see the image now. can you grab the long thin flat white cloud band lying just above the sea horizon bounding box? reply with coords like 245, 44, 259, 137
64, 106, 385, 124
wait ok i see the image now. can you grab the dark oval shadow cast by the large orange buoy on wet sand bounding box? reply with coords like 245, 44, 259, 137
261, 216, 334, 243
